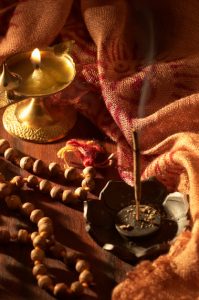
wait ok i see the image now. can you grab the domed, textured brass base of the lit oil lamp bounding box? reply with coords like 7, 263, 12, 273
3, 99, 76, 143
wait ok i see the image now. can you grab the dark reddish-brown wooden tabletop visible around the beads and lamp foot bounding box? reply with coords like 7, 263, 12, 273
0, 110, 132, 300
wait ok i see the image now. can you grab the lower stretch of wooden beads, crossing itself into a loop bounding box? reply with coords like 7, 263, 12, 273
0, 177, 93, 298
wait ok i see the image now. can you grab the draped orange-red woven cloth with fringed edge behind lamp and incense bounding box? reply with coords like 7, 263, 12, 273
0, 0, 199, 300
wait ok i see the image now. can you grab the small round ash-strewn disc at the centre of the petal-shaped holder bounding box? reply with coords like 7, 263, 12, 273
115, 205, 161, 237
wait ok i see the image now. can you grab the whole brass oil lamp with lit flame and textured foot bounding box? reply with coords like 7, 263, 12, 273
0, 42, 76, 143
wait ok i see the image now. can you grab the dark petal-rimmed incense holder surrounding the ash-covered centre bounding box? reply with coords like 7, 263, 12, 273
84, 178, 189, 264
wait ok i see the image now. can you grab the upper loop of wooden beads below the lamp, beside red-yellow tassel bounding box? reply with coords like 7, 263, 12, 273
0, 139, 96, 204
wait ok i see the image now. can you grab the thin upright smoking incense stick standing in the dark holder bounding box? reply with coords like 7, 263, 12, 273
133, 130, 141, 221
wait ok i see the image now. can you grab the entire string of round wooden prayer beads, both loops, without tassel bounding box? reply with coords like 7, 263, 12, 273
0, 139, 96, 298
